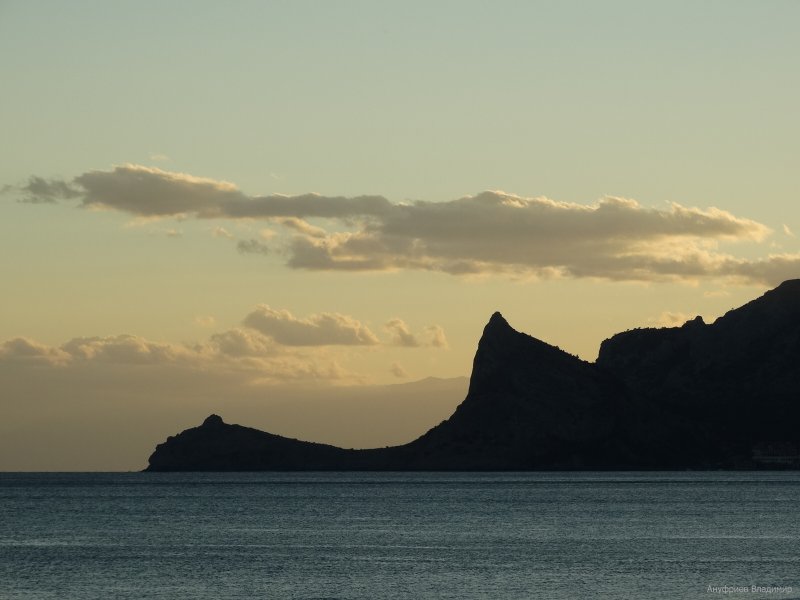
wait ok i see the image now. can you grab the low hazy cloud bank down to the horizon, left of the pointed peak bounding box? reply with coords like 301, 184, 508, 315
0, 327, 467, 471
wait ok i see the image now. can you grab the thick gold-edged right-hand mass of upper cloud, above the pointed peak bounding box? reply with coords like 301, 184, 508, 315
289, 192, 768, 279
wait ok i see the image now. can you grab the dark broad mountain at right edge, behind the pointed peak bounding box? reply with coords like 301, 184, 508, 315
597, 280, 800, 466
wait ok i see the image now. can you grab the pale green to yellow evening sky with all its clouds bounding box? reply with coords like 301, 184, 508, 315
0, 0, 800, 470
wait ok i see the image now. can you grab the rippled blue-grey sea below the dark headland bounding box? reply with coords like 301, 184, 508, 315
0, 473, 800, 600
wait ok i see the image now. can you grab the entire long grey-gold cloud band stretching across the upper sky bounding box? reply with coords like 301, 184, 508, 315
9, 165, 800, 285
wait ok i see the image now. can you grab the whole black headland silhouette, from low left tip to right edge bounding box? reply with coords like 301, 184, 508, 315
147, 280, 800, 471
